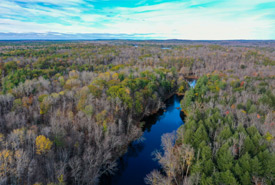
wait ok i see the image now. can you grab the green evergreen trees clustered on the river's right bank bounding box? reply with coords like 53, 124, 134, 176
177, 75, 274, 185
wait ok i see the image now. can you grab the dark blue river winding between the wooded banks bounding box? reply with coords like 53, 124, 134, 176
102, 95, 183, 185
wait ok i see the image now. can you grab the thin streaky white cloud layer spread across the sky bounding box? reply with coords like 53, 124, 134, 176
0, 0, 275, 39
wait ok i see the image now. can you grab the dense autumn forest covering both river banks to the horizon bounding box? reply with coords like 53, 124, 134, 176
0, 41, 275, 185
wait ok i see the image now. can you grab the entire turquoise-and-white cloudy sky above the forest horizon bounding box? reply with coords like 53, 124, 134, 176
0, 0, 275, 40
